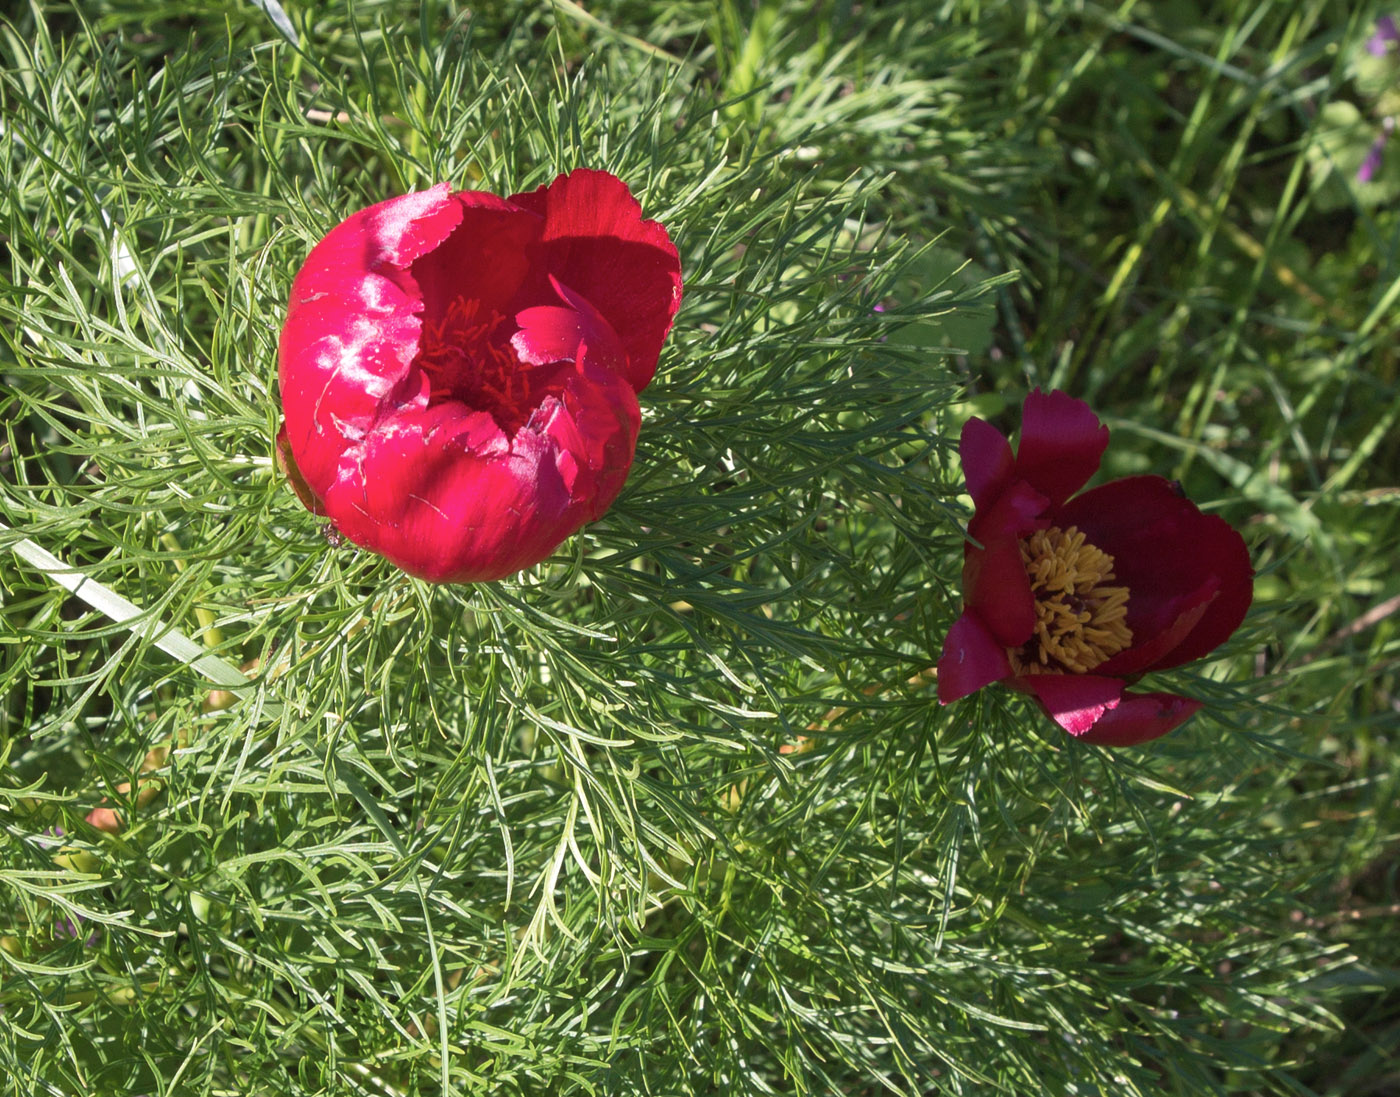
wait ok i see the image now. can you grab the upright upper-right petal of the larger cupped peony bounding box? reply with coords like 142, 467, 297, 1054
511, 168, 680, 392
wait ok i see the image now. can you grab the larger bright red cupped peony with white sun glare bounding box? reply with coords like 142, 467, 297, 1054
277, 169, 680, 582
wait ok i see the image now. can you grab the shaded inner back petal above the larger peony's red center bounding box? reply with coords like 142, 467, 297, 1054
413, 190, 545, 330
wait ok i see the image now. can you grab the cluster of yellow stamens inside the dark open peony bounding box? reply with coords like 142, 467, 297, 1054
1008, 526, 1133, 674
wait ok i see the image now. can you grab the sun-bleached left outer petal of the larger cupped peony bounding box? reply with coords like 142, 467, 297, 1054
277, 185, 461, 497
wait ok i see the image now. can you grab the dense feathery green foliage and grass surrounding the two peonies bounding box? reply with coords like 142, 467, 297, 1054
0, 0, 1400, 1097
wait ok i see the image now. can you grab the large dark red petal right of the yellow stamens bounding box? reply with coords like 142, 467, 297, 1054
1056, 476, 1254, 672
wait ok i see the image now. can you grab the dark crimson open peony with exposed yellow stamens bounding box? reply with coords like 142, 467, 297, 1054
938, 389, 1254, 746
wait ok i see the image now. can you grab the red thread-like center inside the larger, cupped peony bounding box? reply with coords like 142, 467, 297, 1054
413, 297, 547, 435
